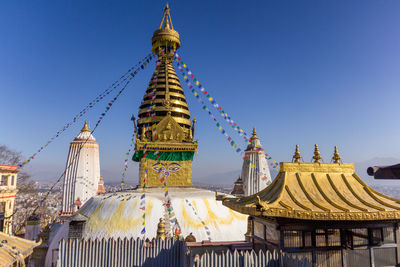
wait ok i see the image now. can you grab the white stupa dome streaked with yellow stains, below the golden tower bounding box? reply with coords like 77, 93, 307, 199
73, 187, 247, 241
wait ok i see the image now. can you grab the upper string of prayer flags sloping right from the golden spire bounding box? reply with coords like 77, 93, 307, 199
174, 53, 249, 141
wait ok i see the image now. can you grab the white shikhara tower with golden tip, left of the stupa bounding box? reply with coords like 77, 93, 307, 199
61, 121, 100, 216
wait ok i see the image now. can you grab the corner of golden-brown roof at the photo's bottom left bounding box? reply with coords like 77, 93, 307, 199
0, 232, 40, 266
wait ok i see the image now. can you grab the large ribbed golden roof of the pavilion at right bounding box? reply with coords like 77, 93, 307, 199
223, 157, 400, 220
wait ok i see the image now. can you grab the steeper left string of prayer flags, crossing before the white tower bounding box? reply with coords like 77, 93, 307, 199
12, 54, 154, 232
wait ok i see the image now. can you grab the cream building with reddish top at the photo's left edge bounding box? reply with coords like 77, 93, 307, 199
0, 165, 18, 234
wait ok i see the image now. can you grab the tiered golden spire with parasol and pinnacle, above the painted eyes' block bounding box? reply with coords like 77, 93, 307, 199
138, 4, 191, 140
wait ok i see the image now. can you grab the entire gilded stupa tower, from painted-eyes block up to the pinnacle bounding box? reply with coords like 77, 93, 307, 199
133, 4, 197, 187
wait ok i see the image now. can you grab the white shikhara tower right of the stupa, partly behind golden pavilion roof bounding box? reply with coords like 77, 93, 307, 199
242, 128, 271, 196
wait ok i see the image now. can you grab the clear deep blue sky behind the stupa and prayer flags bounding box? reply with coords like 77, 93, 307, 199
0, 0, 400, 186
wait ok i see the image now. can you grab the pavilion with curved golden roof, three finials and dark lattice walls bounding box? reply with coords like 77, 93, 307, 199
222, 145, 400, 266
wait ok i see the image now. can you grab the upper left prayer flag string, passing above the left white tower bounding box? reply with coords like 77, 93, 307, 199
19, 53, 155, 168
